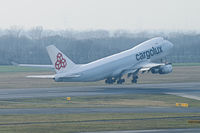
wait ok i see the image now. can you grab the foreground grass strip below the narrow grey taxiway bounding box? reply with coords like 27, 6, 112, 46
0, 113, 200, 133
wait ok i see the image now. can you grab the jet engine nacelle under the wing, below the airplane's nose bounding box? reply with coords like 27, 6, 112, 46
151, 64, 172, 74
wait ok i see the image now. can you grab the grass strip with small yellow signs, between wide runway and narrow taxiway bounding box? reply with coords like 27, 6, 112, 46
0, 94, 200, 109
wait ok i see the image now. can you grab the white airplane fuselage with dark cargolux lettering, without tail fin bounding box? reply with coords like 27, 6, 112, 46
55, 37, 172, 82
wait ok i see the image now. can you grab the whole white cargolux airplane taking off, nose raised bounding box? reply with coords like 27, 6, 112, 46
16, 37, 173, 84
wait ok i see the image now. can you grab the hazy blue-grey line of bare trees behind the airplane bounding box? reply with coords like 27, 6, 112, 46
0, 27, 200, 65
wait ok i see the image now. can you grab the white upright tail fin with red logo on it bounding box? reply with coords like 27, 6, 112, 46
47, 45, 76, 73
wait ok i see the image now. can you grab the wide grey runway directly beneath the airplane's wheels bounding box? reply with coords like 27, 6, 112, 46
0, 83, 200, 99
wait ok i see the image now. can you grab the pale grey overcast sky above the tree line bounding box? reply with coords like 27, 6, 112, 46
0, 0, 200, 31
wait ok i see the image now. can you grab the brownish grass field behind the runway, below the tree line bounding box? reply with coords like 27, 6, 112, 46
0, 66, 200, 89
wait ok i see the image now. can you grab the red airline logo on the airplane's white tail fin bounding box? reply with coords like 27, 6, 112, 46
55, 53, 67, 70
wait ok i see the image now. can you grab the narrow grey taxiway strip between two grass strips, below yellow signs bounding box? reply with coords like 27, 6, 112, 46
0, 107, 200, 115
